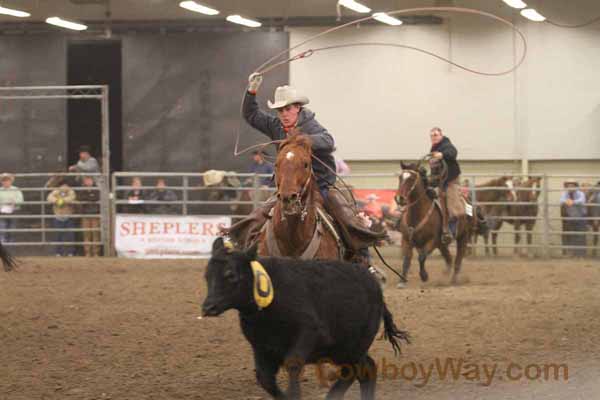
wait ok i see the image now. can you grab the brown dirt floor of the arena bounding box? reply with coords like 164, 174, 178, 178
0, 253, 600, 400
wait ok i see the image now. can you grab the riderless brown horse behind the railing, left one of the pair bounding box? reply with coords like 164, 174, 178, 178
473, 176, 517, 256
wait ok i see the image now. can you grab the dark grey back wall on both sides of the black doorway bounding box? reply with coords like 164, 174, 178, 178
0, 32, 289, 172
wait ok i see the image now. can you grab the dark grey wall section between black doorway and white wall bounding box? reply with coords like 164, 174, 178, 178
123, 32, 289, 171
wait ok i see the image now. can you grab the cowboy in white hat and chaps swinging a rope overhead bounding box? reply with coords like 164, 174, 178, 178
225, 73, 385, 263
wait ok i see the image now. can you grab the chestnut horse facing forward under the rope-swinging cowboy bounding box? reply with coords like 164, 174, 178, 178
258, 135, 342, 259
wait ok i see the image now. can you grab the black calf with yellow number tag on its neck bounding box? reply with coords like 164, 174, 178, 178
202, 239, 409, 399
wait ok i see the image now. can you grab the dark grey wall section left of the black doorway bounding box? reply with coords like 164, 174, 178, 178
0, 35, 66, 172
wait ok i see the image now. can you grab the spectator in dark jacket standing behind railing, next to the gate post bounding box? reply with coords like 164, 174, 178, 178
77, 176, 100, 257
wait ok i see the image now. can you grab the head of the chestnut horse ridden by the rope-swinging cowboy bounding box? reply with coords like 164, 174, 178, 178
275, 135, 312, 215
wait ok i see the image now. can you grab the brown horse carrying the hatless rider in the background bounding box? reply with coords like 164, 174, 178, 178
396, 163, 472, 288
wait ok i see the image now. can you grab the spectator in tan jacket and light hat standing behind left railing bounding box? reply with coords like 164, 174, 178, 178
48, 183, 77, 256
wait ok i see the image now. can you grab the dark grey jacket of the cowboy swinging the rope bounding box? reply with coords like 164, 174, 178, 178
242, 92, 335, 188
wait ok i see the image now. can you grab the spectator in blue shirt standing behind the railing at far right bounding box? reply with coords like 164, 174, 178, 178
560, 181, 587, 257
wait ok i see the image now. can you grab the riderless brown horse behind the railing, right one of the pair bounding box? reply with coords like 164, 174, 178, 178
492, 177, 542, 254
